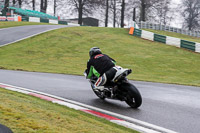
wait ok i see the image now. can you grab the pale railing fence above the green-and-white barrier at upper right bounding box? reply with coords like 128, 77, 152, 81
137, 21, 200, 37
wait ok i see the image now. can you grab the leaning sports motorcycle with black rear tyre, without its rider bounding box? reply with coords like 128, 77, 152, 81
84, 69, 142, 108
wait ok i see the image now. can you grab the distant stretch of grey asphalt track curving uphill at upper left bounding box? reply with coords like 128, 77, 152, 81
0, 25, 70, 47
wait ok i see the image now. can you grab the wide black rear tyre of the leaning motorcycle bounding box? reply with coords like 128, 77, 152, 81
122, 83, 142, 108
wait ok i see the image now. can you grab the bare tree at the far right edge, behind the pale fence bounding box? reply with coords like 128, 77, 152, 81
182, 0, 200, 30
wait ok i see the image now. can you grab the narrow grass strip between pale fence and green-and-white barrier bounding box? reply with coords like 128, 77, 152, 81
144, 29, 200, 42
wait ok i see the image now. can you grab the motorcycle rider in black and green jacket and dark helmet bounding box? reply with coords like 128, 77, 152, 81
85, 47, 128, 89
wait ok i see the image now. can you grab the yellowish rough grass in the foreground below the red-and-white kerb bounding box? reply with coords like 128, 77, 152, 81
0, 88, 136, 133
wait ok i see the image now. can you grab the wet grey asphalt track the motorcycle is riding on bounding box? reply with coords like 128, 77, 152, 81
0, 70, 200, 133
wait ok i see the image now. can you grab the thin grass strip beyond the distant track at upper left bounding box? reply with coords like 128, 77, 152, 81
0, 21, 49, 29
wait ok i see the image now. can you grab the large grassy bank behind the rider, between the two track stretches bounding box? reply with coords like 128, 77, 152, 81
0, 27, 200, 86
